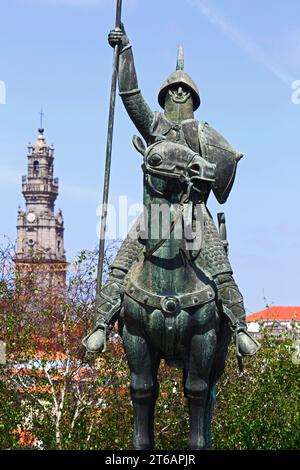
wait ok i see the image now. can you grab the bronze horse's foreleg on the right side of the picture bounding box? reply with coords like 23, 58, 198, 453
185, 330, 217, 450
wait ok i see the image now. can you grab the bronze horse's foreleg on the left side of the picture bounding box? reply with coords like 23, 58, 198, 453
123, 326, 159, 450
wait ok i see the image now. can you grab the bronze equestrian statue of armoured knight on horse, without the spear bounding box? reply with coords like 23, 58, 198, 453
83, 26, 259, 450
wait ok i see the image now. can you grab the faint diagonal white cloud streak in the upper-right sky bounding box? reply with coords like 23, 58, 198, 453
187, 0, 294, 86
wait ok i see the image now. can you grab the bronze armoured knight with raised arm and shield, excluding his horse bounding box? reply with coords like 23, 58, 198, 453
83, 26, 259, 356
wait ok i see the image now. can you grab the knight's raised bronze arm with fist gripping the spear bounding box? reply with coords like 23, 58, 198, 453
108, 25, 154, 141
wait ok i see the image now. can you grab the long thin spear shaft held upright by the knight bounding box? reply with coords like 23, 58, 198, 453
96, 0, 122, 307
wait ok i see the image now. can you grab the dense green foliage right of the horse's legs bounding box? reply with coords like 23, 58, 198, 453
213, 333, 300, 450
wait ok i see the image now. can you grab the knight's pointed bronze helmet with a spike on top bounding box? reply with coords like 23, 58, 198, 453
158, 46, 200, 111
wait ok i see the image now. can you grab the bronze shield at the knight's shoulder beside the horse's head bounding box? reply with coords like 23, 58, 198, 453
199, 122, 243, 204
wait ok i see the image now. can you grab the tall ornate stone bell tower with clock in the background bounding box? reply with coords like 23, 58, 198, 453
14, 124, 68, 294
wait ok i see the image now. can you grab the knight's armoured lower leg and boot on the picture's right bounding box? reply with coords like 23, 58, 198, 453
215, 273, 260, 356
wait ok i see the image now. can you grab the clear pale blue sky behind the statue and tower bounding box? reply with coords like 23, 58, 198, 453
0, 0, 300, 313
